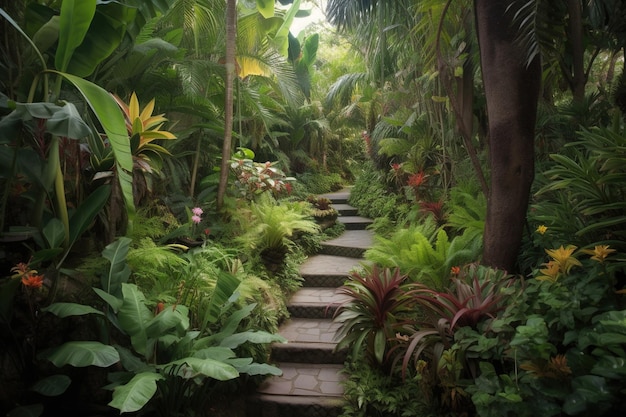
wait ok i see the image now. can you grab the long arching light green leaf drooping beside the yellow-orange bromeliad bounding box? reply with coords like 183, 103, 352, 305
54, 71, 135, 231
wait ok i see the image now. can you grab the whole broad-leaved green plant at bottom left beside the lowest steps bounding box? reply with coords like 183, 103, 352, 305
40, 238, 284, 415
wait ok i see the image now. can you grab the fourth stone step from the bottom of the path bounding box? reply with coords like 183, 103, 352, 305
300, 254, 362, 287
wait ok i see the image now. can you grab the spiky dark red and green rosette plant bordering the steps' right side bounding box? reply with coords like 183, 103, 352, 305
334, 265, 414, 367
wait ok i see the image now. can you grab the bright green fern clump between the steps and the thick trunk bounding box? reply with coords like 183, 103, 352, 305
365, 218, 482, 290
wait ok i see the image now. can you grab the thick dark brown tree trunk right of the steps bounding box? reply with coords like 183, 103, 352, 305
474, 0, 541, 271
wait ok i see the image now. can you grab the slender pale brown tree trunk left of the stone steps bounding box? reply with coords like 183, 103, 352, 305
217, 0, 237, 210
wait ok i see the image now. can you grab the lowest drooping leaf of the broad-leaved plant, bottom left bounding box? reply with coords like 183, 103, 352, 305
109, 372, 163, 413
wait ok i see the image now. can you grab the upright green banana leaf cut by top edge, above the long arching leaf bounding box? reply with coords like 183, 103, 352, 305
54, 0, 97, 72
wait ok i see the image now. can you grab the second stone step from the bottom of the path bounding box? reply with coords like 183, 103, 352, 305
272, 318, 346, 364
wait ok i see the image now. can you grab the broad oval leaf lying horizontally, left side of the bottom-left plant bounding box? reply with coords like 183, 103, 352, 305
43, 341, 120, 368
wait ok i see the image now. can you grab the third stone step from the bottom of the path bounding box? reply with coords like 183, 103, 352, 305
287, 287, 349, 319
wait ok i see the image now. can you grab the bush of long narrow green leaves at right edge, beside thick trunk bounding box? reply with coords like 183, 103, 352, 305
531, 128, 626, 251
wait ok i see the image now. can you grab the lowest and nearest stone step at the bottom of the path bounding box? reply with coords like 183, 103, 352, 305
246, 363, 345, 417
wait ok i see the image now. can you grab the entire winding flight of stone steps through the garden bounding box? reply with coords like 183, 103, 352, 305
247, 190, 373, 417
